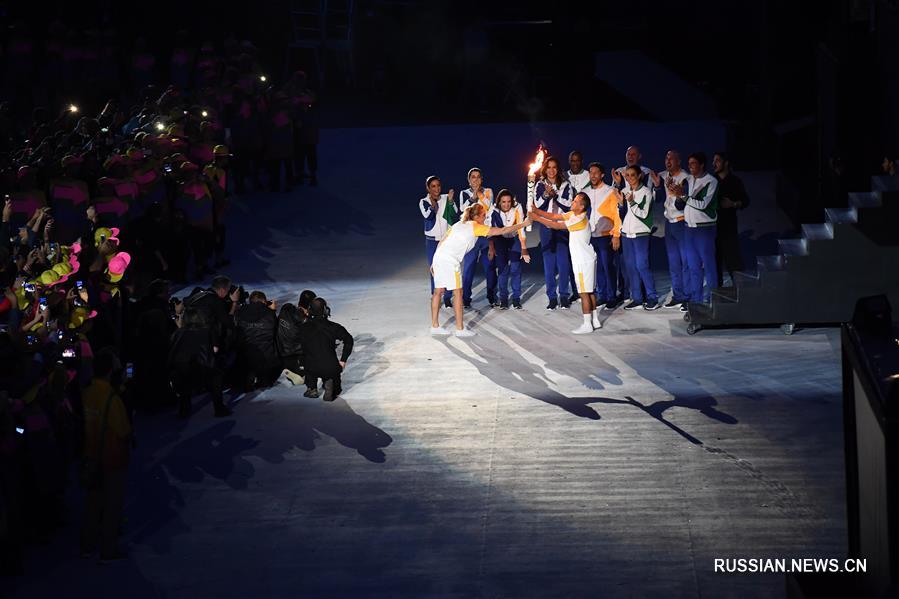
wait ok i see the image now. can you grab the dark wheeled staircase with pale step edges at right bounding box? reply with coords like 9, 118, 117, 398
684, 177, 899, 335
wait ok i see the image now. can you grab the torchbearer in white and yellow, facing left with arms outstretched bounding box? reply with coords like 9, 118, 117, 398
530, 192, 602, 335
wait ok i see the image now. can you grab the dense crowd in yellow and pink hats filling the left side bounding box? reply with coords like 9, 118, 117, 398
0, 23, 330, 574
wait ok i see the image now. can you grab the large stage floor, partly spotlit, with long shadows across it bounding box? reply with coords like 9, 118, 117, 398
13, 122, 846, 598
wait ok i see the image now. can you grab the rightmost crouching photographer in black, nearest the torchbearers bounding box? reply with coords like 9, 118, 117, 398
299, 297, 353, 401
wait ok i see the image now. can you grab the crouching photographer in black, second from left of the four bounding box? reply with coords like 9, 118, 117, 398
237, 291, 282, 391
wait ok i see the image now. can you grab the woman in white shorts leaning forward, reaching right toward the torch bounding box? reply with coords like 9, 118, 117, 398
431, 203, 531, 337
